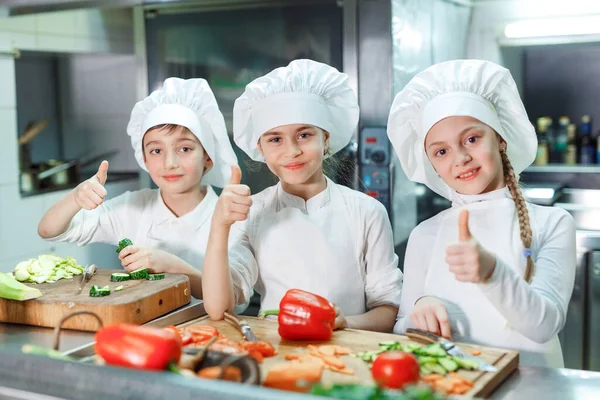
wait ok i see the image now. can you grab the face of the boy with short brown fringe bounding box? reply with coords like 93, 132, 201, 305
142, 125, 213, 194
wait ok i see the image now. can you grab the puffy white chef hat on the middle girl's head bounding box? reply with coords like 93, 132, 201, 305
233, 60, 359, 161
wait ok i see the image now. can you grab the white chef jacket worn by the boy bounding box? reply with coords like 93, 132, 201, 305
49, 186, 219, 270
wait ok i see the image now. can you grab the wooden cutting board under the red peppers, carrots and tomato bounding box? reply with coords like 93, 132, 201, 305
179, 316, 519, 397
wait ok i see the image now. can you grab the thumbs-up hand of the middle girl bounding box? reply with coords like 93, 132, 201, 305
213, 165, 252, 228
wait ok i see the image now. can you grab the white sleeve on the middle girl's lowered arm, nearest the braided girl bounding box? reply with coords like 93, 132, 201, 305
363, 201, 402, 309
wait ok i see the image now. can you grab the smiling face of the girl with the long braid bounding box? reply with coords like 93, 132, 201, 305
425, 116, 506, 194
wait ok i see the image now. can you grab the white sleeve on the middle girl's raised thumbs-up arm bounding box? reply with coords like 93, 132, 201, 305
229, 217, 258, 305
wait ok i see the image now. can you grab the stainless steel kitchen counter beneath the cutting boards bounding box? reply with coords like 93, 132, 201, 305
0, 300, 600, 400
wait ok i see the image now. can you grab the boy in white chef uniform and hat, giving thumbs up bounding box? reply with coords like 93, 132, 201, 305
38, 78, 237, 298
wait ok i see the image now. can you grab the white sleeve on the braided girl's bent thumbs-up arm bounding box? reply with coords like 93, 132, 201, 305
478, 210, 576, 343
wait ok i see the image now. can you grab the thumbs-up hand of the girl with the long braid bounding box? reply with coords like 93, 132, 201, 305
446, 210, 496, 283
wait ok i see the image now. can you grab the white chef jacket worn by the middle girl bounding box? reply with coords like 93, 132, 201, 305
229, 179, 402, 315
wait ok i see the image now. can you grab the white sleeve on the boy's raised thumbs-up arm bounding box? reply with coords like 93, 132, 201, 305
48, 192, 139, 246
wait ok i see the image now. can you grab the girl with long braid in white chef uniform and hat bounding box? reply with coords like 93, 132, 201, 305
388, 60, 575, 367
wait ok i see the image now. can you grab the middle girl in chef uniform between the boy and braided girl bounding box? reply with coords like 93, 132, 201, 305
202, 60, 402, 331
